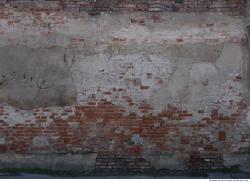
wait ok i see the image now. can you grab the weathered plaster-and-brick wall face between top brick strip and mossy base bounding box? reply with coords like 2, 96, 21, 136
0, 1, 250, 172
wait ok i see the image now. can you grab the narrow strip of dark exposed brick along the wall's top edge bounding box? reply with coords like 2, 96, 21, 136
0, 0, 245, 15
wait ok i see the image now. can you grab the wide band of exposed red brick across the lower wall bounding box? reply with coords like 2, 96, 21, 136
0, 100, 249, 171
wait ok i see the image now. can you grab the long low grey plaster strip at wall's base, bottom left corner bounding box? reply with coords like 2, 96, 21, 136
0, 154, 97, 171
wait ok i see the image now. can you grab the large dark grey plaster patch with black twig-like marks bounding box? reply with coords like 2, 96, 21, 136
0, 45, 76, 109
